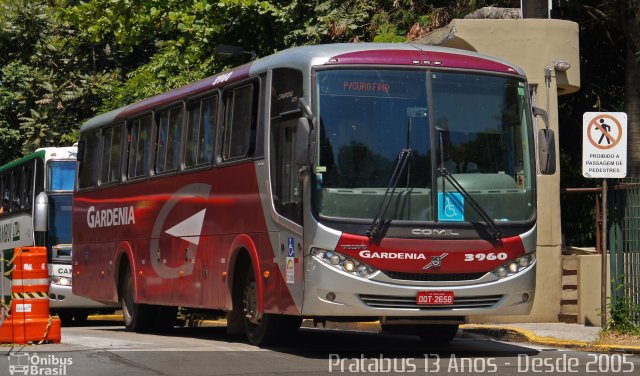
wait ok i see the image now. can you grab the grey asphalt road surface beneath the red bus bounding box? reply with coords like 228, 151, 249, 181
0, 324, 640, 376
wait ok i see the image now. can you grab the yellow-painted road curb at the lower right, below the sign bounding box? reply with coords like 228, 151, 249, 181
461, 324, 640, 354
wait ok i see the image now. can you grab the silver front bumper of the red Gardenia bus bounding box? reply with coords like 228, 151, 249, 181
302, 255, 536, 317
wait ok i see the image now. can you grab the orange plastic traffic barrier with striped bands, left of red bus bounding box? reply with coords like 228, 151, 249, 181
0, 247, 61, 344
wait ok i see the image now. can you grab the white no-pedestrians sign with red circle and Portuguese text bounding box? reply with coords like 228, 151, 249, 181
582, 112, 627, 178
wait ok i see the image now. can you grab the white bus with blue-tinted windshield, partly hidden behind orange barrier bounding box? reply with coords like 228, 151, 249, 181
0, 146, 111, 323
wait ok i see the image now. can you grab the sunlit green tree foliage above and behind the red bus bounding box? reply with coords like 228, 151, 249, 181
0, 0, 516, 159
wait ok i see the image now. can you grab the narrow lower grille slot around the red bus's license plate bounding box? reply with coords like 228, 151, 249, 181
360, 295, 503, 311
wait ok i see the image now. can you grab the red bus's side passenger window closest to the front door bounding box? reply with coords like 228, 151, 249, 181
222, 84, 258, 160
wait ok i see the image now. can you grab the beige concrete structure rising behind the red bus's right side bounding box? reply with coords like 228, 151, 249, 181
413, 19, 580, 322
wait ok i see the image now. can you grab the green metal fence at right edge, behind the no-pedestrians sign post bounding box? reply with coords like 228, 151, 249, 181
608, 178, 640, 324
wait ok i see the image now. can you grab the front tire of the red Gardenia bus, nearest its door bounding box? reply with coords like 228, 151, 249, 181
242, 269, 302, 346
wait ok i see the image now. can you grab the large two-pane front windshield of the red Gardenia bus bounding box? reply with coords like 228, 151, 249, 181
314, 69, 535, 222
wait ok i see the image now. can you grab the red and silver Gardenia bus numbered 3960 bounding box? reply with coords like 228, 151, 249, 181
73, 43, 555, 344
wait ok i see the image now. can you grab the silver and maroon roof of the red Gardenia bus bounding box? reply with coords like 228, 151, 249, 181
80, 43, 524, 132
